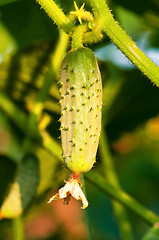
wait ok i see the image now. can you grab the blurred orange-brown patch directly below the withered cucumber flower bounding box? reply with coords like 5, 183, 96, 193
25, 198, 88, 240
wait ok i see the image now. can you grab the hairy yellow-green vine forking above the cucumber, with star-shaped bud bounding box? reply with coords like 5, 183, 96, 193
36, 0, 159, 86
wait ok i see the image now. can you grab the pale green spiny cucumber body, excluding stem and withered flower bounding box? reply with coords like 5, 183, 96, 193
59, 47, 102, 173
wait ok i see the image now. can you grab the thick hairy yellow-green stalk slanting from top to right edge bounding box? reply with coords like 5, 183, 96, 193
89, 0, 159, 87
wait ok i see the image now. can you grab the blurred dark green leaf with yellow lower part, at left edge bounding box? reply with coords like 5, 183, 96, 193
0, 154, 39, 218
